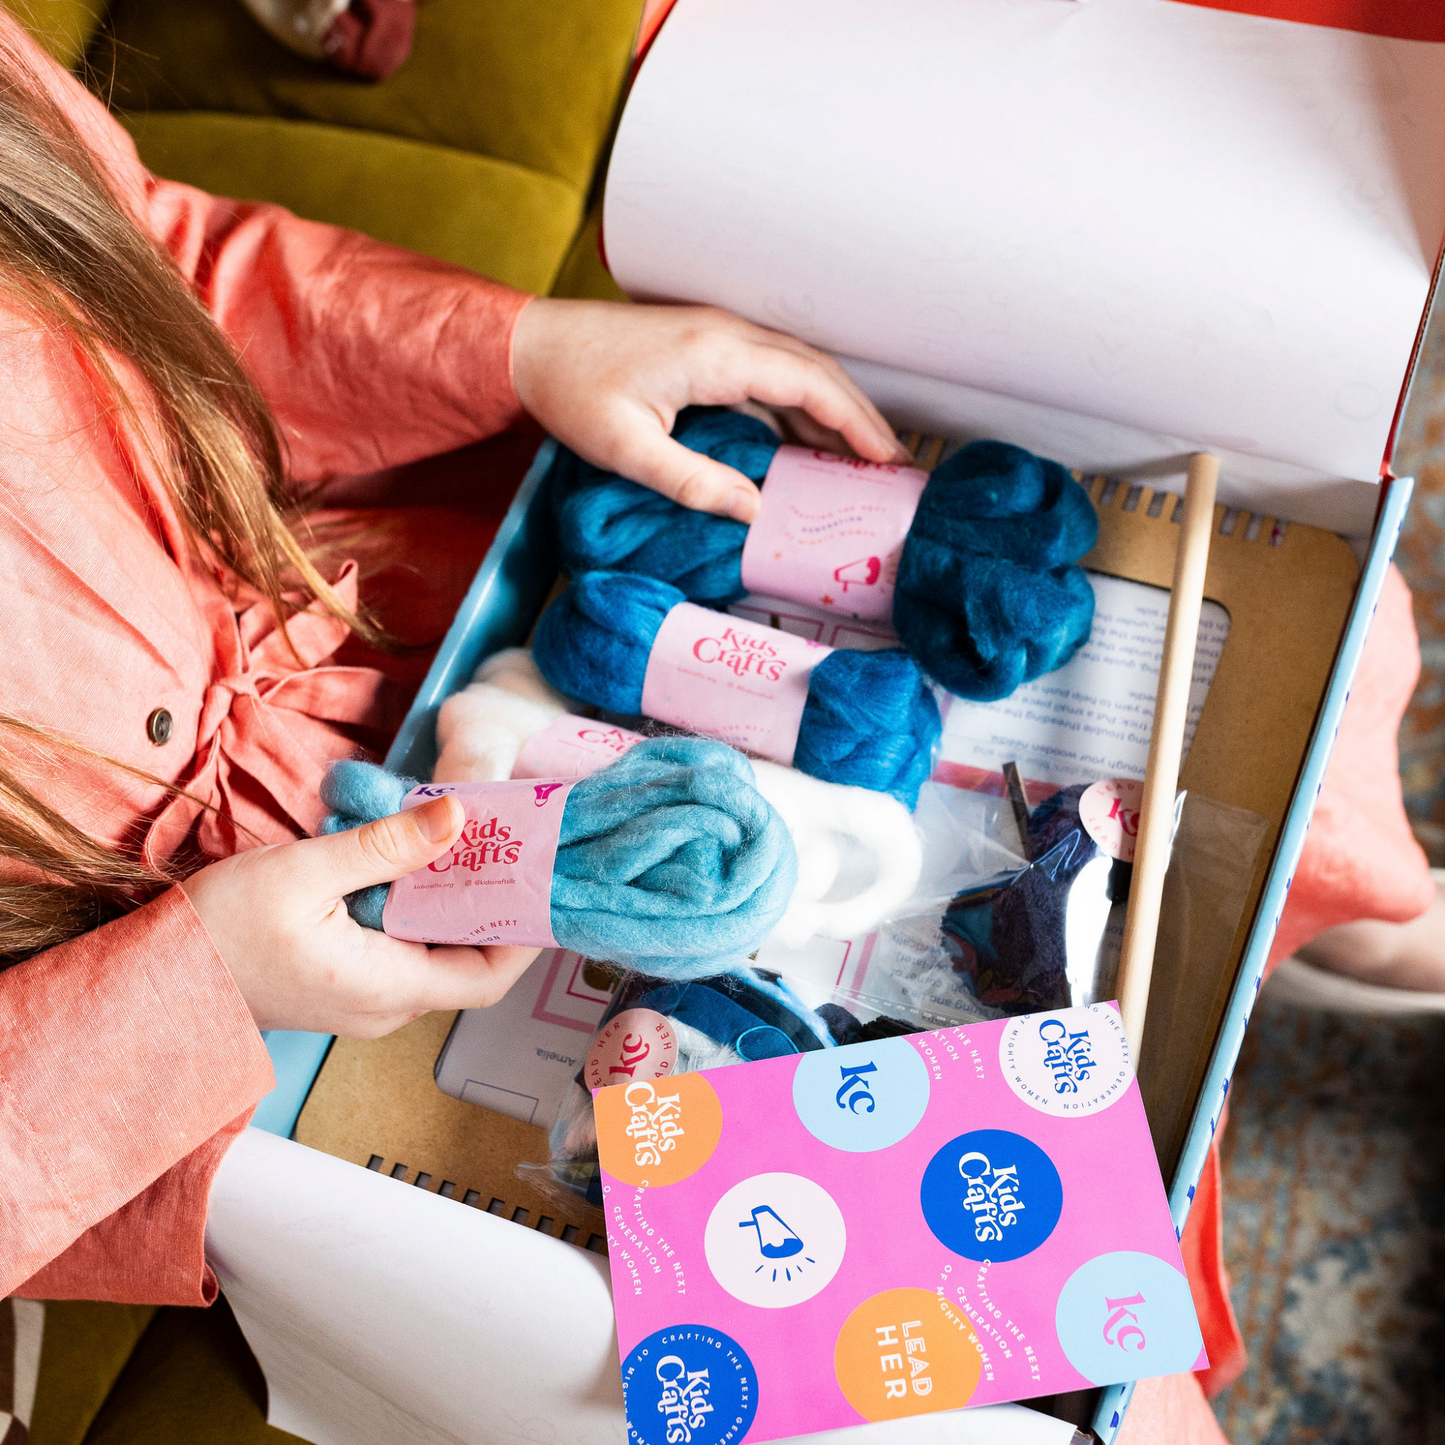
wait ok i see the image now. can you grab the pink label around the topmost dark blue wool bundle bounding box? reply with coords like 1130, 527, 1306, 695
743, 447, 928, 621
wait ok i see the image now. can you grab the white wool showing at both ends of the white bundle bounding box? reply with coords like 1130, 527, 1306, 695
432, 647, 923, 948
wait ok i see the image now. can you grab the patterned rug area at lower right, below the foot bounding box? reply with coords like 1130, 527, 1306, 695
1214, 993, 1445, 1445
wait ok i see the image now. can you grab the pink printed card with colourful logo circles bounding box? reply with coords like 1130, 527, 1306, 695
595, 1004, 1208, 1445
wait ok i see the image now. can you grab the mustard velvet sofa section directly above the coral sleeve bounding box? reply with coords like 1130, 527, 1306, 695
124, 111, 582, 293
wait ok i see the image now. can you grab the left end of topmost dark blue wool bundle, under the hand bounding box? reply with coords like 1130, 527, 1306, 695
551, 407, 779, 607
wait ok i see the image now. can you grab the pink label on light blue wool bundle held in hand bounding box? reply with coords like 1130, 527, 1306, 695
381, 780, 572, 948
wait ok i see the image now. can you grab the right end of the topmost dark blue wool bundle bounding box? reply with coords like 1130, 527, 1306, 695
893, 442, 1098, 702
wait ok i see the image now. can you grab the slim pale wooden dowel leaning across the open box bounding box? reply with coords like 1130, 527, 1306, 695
1116, 452, 1220, 1065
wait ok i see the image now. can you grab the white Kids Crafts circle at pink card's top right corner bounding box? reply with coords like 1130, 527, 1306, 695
998, 1003, 1134, 1118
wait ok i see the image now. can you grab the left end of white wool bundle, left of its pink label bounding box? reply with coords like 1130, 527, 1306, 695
432, 647, 566, 783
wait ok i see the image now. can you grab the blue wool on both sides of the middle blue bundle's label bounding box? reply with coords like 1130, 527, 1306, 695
532, 572, 942, 808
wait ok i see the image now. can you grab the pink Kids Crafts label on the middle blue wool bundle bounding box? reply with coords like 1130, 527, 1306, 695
642, 603, 832, 763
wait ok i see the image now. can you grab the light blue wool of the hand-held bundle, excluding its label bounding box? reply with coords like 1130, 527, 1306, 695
321, 737, 798, 980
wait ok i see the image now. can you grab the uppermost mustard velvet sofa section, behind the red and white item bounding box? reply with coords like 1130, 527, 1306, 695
91, 0, 642, 194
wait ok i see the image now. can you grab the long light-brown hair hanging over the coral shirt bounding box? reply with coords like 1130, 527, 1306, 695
0, 31, 377, 968
